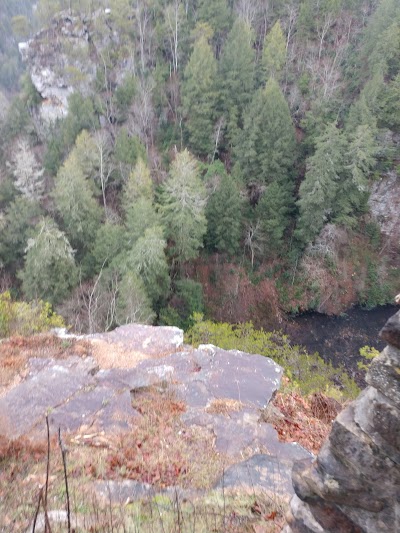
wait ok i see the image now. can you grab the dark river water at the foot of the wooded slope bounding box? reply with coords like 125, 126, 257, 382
286, 305, 399, 378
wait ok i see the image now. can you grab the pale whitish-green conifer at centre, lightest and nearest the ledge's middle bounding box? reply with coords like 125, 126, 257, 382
160, 150, 207, 262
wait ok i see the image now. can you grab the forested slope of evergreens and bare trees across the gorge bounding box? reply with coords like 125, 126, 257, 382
0, 0, 400, 333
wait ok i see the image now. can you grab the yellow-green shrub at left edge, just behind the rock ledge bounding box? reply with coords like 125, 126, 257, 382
0, 291, 64, 338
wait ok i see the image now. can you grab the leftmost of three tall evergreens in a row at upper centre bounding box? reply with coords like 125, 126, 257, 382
182, 35, 217, 155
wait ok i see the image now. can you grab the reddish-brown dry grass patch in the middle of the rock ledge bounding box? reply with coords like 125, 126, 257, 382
107, 386, 223, 488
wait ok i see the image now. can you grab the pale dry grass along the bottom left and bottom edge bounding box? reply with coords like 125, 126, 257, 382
0, 426, 285, 533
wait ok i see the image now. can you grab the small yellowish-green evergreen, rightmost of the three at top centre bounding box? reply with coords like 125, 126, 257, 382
260, 20, 286, 84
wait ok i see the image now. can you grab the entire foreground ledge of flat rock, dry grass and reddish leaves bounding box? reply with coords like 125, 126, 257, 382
0, 325, 339, 533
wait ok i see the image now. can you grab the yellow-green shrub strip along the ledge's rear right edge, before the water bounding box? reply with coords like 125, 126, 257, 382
186, 313, 359, 399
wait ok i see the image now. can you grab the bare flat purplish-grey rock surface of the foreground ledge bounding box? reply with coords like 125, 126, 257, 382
0, 325, 312, 503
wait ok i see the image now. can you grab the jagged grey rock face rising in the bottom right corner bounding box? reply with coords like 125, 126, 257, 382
285, 311, 400, 533
